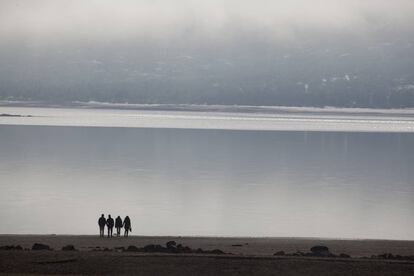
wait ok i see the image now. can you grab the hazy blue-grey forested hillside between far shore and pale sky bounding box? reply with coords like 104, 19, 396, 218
0, 30, 414, 108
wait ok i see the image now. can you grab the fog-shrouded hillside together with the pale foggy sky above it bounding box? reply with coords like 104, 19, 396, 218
0, 0, 414, 108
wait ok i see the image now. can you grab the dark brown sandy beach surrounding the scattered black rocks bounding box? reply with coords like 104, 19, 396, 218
0, 235, 414, 275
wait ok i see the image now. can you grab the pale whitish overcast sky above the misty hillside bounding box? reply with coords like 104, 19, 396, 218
0, 0, 414, 40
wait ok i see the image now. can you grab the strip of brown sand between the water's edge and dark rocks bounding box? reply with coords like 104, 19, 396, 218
0, 234, 414, 257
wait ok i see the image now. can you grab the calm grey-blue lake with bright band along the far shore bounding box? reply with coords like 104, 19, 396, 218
0, 107, 414, 240
